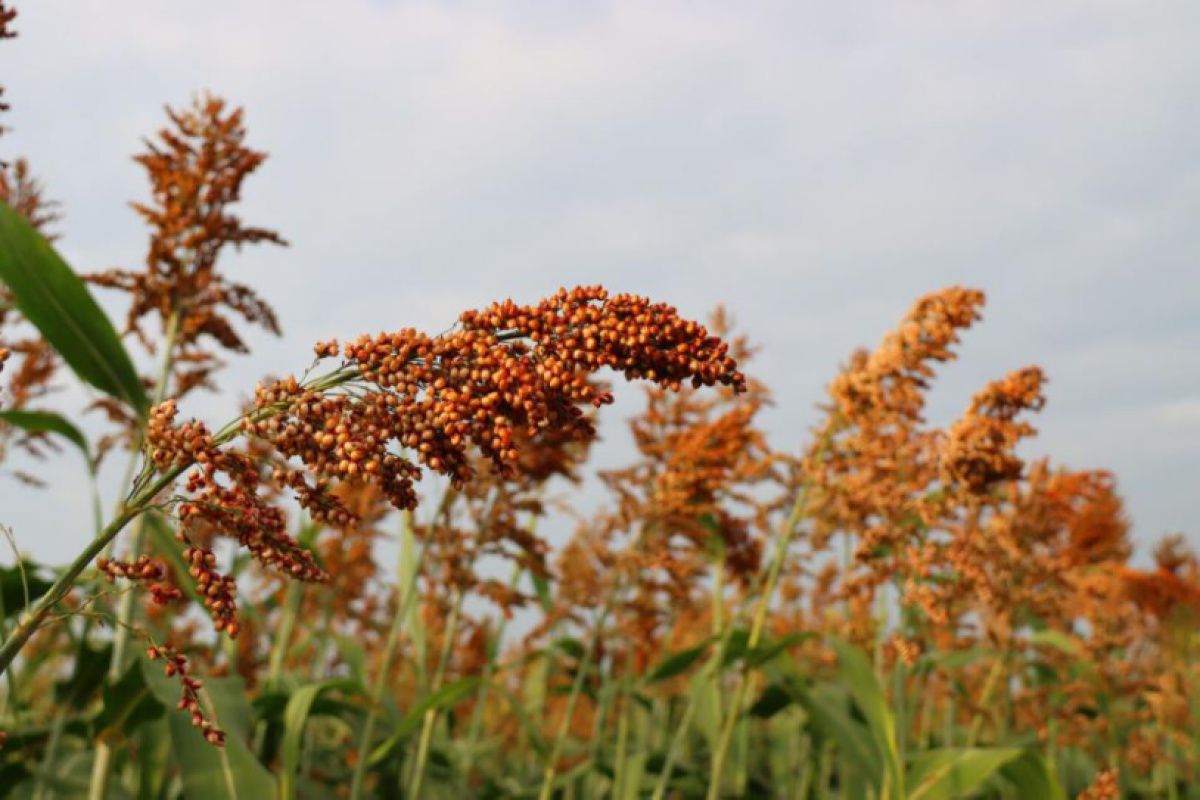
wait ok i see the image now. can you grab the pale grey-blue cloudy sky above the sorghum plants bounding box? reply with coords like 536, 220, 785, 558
0, 0, 1200, 564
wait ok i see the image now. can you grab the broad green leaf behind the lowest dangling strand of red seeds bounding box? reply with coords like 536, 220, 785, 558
140, 658, 277, 800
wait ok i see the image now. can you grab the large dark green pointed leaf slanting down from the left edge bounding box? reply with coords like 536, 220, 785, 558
0, 203, 150, 417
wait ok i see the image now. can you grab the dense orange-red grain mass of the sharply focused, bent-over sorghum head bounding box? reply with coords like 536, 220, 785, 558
242, 287, 745, 509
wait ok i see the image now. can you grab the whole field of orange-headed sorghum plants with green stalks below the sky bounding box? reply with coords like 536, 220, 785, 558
0, 5, 1200, 800
